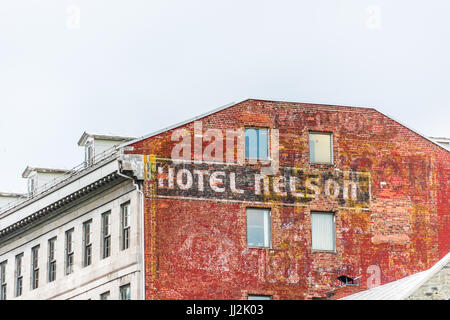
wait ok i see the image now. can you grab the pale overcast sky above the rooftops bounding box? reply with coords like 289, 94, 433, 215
0, 0, 450, 192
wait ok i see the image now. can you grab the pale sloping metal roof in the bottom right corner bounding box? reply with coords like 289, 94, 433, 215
339, 252, 450, 300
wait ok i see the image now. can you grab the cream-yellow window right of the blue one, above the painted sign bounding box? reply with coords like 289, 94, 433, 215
309, 132, 333, 164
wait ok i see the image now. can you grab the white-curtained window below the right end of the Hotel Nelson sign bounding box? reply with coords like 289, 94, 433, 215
311, 212, 336, 251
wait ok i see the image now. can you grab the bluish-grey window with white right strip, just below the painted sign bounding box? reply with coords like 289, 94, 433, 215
247, 208, 271, 248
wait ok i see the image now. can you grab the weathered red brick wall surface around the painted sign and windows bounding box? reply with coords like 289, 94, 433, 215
125, 100, 450, 299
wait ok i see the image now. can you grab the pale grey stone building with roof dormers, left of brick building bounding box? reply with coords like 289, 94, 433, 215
0, 132, 144, 300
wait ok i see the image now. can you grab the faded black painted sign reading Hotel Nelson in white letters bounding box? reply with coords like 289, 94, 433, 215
147, 161, 371, 207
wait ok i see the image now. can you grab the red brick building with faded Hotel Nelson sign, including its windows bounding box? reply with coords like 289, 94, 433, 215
118, 100, 450, 299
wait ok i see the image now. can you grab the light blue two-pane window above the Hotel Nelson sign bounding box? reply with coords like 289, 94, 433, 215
245, 128, 269, 160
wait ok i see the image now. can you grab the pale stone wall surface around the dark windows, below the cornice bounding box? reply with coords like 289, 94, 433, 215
0, 180, 143, 300
